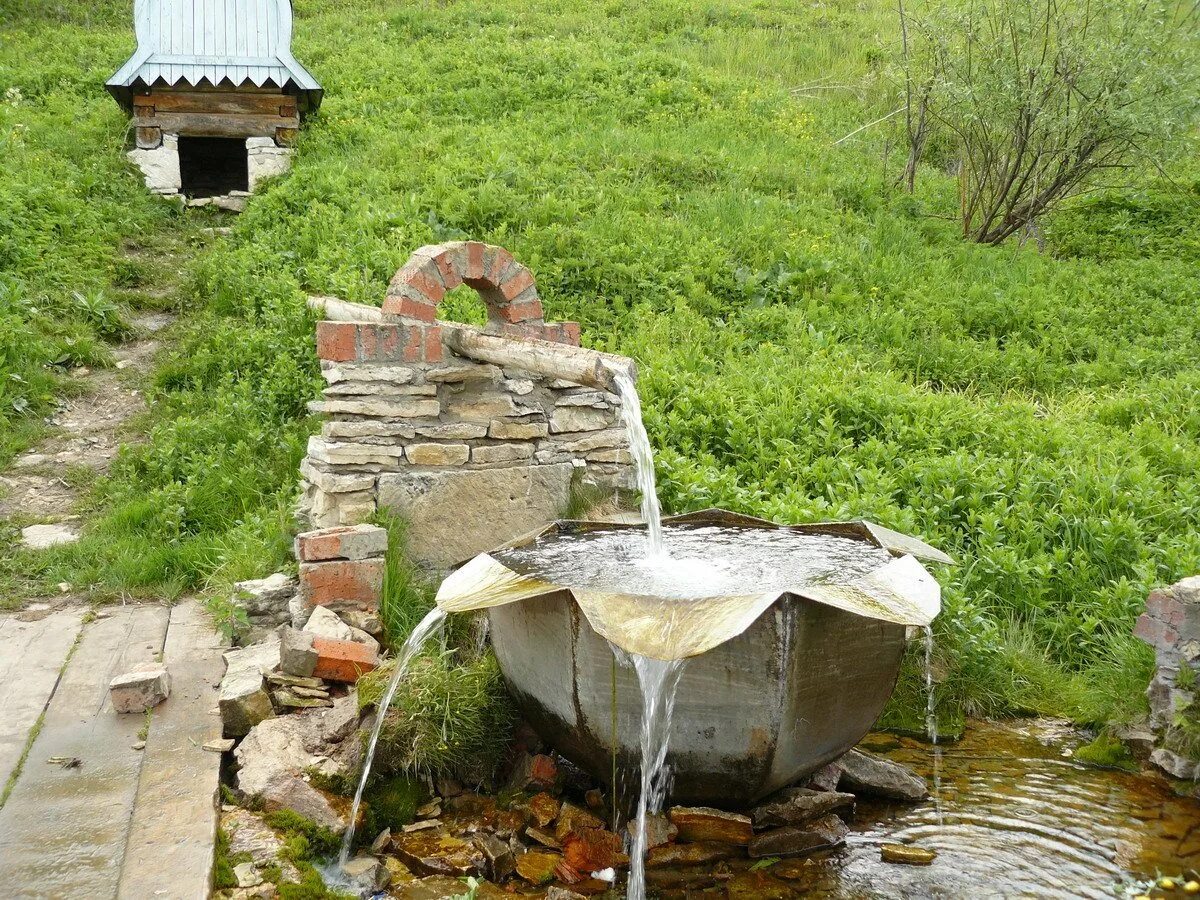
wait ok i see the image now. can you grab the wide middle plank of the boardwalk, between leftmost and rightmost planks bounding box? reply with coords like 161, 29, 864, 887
0, 606, 168, 898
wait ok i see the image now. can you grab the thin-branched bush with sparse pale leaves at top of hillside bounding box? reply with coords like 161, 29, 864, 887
898, 0, 1200, 244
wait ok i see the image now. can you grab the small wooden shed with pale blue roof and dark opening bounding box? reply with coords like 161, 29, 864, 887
104, 0, 323, 198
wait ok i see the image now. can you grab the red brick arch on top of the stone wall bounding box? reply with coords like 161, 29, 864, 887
383, 241, 580, 344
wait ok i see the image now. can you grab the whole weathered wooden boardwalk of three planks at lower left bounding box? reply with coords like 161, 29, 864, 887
0, 601, 223, 898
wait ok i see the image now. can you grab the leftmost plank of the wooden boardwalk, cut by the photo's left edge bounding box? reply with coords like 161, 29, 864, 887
0, 608, 83, 785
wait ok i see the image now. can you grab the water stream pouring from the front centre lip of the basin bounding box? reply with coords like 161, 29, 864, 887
618, 652, 684, 900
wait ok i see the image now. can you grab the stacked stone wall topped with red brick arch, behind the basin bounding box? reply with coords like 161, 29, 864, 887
301, 241, 635, 566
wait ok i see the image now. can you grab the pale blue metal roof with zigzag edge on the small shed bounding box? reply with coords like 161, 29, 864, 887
104, 0, 324, 108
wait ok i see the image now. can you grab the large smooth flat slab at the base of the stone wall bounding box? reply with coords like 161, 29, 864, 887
379, 463, 574, 566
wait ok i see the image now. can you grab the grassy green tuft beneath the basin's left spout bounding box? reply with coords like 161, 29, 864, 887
359, 650, 515, 784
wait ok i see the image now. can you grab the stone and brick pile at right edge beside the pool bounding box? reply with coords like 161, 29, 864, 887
1134, 575, 1200, 780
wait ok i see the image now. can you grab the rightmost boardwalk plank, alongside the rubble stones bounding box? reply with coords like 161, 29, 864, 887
118, 600, 224, 900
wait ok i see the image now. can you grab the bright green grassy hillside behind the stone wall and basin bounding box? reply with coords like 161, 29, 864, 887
0, 0, 1200, 719
